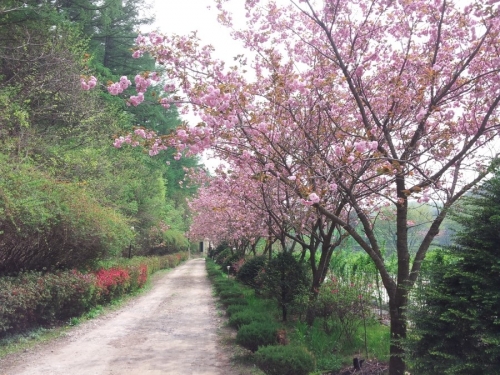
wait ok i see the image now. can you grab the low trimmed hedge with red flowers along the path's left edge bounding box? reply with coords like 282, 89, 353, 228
0, 253, 187, 337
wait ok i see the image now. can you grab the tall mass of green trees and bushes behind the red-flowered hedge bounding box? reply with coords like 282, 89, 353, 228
0, 0, 197, 272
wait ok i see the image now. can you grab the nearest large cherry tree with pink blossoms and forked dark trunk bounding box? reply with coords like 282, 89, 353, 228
94, 0, 500, 375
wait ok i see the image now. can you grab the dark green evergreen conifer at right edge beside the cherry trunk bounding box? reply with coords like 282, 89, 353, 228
409, 173, 500, 375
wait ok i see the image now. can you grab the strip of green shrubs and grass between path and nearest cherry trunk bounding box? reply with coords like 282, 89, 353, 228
207, 253, 389, 374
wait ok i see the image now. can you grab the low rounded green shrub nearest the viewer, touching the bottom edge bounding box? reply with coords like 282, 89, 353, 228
254, 345, 315, 375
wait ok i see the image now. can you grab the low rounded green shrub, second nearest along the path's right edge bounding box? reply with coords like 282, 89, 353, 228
236, 322, 279, 352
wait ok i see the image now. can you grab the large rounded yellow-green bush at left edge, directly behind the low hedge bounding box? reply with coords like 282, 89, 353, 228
0, 159, 131, 274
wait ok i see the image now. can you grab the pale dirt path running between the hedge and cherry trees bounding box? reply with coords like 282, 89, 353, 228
0, 259, 242, 375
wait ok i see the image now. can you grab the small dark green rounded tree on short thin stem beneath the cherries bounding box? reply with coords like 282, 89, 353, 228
259, 253, 309, 321
